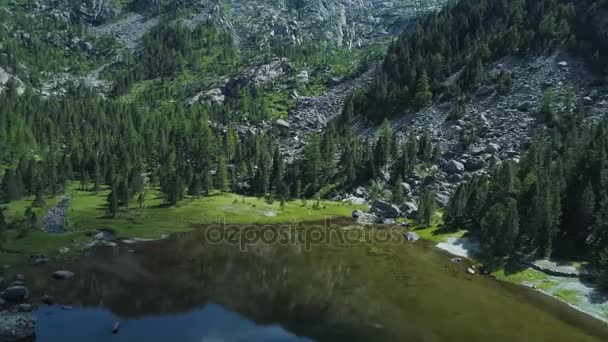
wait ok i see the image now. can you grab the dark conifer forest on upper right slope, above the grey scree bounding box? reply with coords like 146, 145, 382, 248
342, 0, 608, 123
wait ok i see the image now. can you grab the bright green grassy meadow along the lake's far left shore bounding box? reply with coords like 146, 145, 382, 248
0, 185, 361, 264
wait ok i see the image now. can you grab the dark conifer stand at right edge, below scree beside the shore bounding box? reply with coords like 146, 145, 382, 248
444, 90, 608, 285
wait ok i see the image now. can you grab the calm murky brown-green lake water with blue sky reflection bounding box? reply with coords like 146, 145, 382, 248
24, 223, 608, 342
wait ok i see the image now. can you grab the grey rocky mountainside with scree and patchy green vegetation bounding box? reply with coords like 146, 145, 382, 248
0, 0, 608, 207
